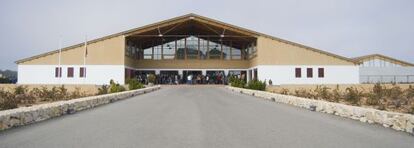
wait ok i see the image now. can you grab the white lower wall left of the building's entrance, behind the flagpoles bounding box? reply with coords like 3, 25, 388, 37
17, 65, 125, 85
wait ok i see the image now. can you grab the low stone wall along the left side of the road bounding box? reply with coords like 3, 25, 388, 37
0, 86, 160, 130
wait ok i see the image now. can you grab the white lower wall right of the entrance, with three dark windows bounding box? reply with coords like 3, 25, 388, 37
251, 65, 359, 85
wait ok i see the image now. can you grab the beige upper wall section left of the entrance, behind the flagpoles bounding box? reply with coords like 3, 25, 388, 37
19, 35, 125, 65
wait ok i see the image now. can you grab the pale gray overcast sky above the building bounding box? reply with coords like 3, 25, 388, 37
0, 0, 414, 70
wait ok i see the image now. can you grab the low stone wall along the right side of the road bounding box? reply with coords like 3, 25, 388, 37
226, 86, 414, 134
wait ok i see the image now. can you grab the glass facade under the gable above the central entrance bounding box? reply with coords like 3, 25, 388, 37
125, 36, 256, 60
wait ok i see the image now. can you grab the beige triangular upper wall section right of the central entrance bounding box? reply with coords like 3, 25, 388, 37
251, 36, 355, 66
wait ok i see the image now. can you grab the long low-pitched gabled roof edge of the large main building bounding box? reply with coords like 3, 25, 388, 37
15, 13, 355, 64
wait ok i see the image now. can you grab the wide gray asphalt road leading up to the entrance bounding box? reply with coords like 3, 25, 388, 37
0, 86, 414, 148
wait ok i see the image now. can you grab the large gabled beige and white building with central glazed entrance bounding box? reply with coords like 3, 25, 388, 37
16, 14, 410, 84
